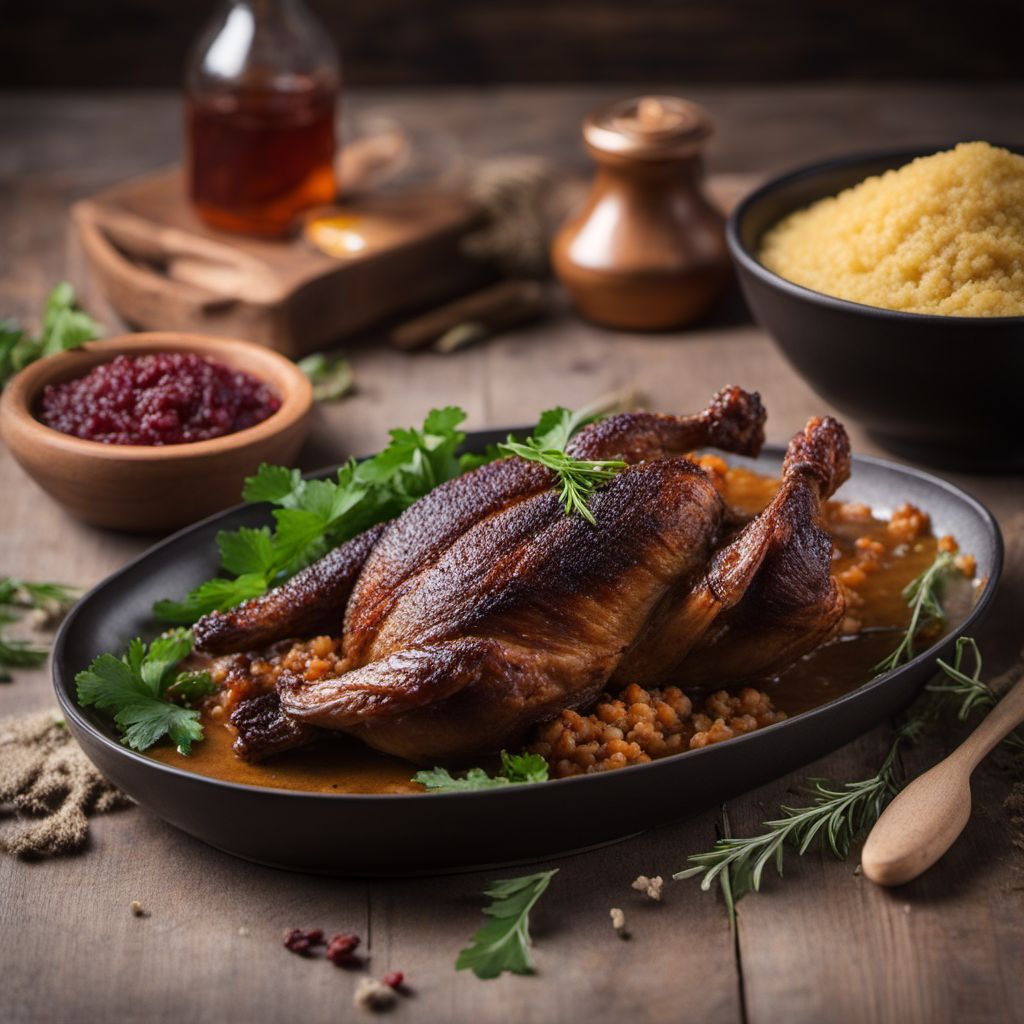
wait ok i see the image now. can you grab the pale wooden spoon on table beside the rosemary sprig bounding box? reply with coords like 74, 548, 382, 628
860, 677, 1024, 886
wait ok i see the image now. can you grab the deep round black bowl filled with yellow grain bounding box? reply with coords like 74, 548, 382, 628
726, 144, 1024, 471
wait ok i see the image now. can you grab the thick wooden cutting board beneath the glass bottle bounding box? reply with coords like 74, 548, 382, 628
71, 169, 488, 357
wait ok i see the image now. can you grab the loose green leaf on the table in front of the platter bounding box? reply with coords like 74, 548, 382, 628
455, 868, 558, 978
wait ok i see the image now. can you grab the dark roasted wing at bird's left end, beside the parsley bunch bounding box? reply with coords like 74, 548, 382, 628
193, 524, 384, 654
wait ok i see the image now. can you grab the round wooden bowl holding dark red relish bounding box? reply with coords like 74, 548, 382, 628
0, 331, 313, 532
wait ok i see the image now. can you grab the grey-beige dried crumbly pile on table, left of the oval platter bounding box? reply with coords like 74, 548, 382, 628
0, 711, 131, 857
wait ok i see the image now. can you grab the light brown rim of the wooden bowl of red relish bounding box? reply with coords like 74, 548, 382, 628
0, 331, 313, 462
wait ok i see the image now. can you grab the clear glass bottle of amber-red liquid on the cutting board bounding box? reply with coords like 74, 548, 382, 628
185, 0, 341, 237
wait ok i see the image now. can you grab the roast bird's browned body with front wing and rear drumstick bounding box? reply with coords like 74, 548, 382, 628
278, 388, 764, 762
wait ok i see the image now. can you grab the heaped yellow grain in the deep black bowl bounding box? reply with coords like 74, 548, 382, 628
759, 142, 1024, 316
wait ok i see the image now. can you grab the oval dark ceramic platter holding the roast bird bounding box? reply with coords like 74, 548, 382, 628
52, 431, 1002, 876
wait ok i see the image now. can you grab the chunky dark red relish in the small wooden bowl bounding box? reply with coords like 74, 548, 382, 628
40, 352, 281, 444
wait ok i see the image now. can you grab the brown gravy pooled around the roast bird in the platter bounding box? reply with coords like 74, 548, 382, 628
151, 460, 974, 795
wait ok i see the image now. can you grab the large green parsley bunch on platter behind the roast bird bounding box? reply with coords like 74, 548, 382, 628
154, 407, 466, 626
